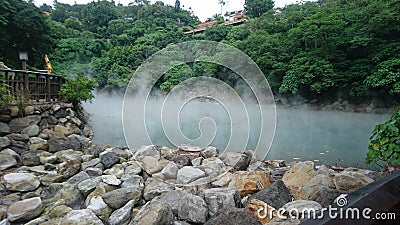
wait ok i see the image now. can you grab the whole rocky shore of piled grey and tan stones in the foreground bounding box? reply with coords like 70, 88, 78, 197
0, 104, 383, 225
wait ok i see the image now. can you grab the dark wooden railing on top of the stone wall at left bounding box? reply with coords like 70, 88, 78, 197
0, 69, 65, 102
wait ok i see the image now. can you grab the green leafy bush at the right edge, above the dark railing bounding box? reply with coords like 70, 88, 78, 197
366, 107, 400, 165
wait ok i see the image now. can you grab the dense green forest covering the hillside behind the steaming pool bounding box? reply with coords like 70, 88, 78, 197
0, 0, 400, 102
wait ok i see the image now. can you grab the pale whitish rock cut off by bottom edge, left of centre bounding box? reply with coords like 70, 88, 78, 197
59, 209, 103, 225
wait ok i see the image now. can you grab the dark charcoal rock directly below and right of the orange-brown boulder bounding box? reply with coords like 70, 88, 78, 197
248, 180, 291, 209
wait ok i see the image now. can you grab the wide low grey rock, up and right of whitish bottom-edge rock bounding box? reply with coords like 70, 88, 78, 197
102, 188, 142, 209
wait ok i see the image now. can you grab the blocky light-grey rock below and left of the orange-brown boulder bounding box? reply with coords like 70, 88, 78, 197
204, 188, 240, 217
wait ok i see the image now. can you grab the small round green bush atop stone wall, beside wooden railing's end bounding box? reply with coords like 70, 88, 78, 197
60, 75, 97, 105
